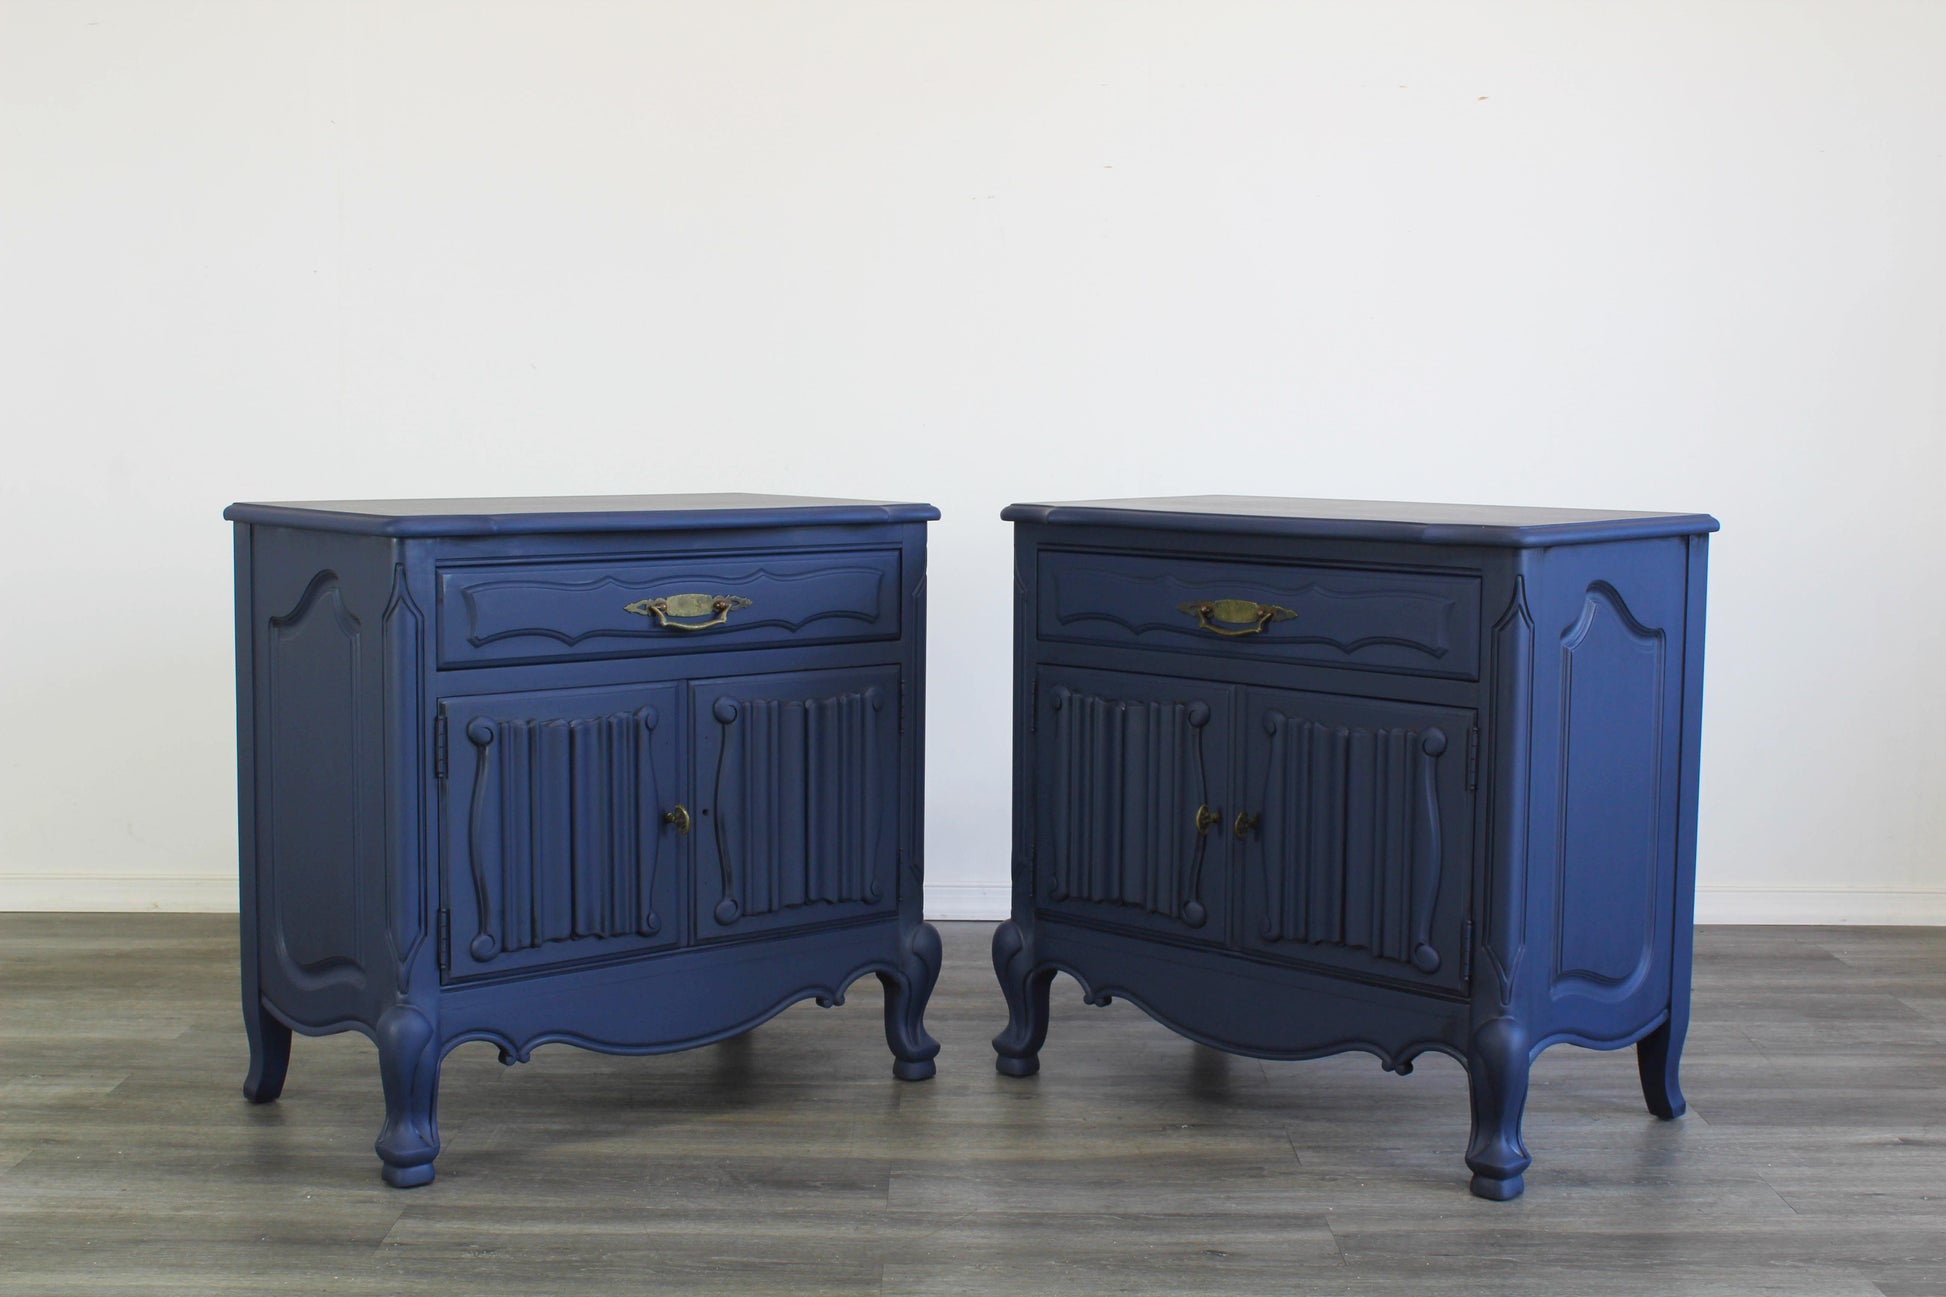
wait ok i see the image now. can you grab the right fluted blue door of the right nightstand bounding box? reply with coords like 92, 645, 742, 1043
1226, 689, 1473, 989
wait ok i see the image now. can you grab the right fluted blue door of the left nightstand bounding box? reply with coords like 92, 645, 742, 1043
691, 666, 899, 941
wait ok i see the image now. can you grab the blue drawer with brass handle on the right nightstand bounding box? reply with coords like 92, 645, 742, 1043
1037, 549, 1479, 680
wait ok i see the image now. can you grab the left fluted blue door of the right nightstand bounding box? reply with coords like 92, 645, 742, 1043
1033, 668, 1234, 943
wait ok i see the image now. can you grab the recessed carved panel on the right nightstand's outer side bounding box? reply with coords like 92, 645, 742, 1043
1555, 580, 1668, 999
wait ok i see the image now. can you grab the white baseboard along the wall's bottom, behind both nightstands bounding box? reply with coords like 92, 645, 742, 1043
0, 871, 1946, 927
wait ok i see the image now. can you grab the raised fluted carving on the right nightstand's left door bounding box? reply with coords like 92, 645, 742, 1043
1043, 686, 1210, 927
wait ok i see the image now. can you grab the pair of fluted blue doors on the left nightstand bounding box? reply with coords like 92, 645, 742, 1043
438, 666, 899, 978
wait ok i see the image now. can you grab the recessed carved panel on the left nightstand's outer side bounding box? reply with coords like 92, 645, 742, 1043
259, 571, 365, 991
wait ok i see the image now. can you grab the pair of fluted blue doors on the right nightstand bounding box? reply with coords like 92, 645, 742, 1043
1031, 666, 1475, 989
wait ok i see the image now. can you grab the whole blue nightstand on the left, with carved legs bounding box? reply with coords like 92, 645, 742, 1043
228, 497, 940, 1186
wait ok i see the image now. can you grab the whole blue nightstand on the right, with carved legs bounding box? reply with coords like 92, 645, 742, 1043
994, 497, 1716, 1200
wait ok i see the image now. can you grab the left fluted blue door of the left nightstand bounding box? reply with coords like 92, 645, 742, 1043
440, 686, 685, 978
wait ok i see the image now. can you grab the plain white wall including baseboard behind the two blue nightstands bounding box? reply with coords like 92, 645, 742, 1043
0, 0, 1946, 921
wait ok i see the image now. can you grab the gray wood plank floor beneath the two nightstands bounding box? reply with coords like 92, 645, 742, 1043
0, 915, 1946, 1297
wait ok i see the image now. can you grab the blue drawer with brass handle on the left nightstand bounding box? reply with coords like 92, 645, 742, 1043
438, 549, 899, 668
